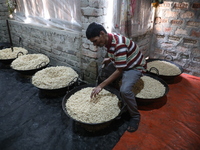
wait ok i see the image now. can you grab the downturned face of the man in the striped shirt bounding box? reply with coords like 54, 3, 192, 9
90, 32, 106, 47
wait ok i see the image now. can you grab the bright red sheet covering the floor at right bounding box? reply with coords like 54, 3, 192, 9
113, 74, 200, 150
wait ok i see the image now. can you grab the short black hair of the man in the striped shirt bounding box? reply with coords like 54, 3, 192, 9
86, 22, 107, 39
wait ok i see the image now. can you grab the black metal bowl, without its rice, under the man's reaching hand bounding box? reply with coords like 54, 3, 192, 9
62, 84, 125, 131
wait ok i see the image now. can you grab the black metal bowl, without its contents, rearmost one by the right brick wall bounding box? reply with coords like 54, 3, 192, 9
146, 59, 183, 84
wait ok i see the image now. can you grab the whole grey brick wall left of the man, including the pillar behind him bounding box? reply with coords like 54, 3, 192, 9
0, 0, 107, 82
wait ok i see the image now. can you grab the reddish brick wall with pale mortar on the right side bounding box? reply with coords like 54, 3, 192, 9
150, 0, 200, 76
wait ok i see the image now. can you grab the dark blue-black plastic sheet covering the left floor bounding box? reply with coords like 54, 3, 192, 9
0, 64, 130, 150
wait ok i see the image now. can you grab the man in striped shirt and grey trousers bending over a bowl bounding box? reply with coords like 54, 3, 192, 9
86, 22, 146, 132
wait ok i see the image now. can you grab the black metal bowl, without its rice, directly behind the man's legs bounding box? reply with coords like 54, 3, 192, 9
136, 73, 169, 104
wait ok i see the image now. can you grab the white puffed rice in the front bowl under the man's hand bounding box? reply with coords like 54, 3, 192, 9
66, 87, 120, 123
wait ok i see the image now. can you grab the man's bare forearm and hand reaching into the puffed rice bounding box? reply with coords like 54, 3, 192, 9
90, 68, 124, 98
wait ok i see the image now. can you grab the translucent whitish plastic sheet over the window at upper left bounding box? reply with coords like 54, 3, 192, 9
13, 0, 81, 31
